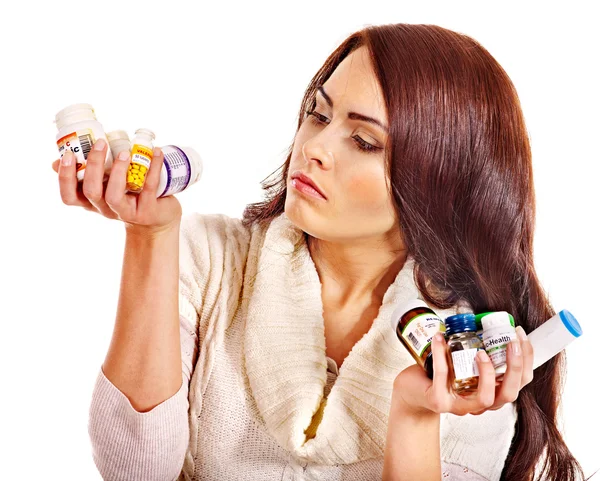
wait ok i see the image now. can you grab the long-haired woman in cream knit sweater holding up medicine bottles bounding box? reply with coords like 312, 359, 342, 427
56, 24, 582, 481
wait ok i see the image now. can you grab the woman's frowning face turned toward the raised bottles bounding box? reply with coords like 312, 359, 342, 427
285, 47, 399, 242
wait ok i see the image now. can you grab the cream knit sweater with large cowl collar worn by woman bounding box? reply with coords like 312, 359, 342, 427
88, 214, 517, 481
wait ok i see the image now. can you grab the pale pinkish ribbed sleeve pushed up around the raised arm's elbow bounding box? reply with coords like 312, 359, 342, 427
88, 315, 198, 481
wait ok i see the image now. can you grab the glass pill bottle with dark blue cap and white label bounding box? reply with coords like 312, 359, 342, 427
444, 314, 485, 394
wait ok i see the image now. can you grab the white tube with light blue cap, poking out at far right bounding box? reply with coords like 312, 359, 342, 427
527, 309, 583, 369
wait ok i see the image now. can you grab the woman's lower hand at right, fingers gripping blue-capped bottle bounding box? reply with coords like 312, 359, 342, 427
392, 327, 533, 416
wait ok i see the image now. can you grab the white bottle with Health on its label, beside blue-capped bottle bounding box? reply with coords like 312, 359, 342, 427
481, 311, 517, 381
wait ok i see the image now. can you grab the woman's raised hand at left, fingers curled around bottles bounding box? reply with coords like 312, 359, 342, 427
52, 139, 182, 237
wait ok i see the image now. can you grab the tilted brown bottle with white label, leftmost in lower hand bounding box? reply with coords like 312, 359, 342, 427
391, 299, 446, 379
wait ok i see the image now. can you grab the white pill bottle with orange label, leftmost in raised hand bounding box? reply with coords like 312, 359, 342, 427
54, 104, 113, 182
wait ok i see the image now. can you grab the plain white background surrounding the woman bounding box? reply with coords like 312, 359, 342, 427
0, 0, 600, 480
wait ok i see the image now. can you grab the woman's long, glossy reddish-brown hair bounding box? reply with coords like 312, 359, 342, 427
243, 24, 584, 481
